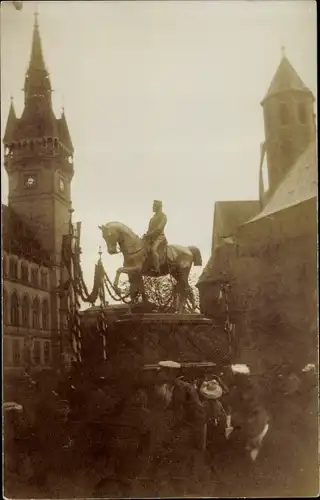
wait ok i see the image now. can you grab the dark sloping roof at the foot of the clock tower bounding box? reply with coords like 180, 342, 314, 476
2, 205, 51, 266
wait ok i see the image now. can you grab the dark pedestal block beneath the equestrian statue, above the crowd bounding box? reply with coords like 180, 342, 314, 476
81, 308, 232, 368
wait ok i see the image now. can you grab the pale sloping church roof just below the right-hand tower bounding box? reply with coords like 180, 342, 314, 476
246, 141, 318, 224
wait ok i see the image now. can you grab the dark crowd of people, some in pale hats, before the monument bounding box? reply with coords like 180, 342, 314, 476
4, 361, 314, 497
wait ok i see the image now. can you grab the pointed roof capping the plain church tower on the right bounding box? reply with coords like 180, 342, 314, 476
261, 54, 314, 104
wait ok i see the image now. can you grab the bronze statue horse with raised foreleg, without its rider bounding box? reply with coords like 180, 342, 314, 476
98, 222, 202, 312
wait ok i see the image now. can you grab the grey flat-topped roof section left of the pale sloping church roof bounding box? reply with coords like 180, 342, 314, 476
212, 200, 260, 247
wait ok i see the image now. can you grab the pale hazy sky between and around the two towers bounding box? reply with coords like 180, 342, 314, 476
1, 0, 317, 292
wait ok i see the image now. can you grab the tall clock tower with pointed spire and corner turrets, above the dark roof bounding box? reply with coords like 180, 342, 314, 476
3, 14, 74, 264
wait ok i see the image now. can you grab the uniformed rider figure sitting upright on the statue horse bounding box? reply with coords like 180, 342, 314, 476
143, 200, 167, 273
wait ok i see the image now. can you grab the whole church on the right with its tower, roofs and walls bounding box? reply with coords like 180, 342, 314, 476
198, 50, 317, 370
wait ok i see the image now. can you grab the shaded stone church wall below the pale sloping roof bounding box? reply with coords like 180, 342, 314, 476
200, 230, 317, 371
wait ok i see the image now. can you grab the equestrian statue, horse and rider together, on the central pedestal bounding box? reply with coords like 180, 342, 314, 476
98, 200, 202, 312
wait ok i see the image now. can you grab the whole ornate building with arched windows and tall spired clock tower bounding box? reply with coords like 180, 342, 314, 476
2, 16, 74, 371
